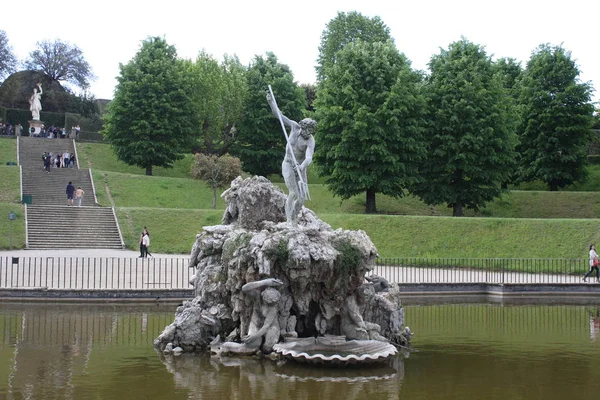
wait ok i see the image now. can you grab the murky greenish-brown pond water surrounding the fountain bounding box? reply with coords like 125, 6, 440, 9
0, 303, 600, 400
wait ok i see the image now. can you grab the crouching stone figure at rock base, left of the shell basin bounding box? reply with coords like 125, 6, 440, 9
211, 278, 283, 355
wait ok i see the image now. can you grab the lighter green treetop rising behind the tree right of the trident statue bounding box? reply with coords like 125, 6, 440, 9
315, 11, 392, 82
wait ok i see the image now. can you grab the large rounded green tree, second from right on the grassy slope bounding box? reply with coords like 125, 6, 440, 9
414, 38, 516, 217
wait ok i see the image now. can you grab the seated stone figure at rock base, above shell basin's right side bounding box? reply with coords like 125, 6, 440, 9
340, 289, 388, 342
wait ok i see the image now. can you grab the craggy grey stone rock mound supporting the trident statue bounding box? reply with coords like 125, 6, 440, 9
155, 177, 405, 354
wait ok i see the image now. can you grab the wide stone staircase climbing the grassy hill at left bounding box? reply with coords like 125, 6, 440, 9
18, 137, 124, 249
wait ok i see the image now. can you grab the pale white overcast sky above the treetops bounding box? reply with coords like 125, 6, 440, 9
0, 0, 600, 102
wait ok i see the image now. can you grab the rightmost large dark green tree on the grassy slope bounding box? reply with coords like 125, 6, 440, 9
519, 44, 594, 191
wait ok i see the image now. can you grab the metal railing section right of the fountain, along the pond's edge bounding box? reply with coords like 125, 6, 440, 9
371, 258, 595, 284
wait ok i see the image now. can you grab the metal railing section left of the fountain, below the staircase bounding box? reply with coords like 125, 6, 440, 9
0, 257, 196, 290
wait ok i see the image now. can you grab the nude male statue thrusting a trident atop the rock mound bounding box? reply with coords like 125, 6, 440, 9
267, 89, 317, 223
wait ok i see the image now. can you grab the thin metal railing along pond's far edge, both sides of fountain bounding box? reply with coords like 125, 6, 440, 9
0, 257, 595, 290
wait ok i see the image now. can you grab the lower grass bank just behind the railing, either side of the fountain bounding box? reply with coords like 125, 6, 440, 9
109, 207, 600, 258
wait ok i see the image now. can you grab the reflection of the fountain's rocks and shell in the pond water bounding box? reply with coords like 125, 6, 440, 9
159, 354, 404, 400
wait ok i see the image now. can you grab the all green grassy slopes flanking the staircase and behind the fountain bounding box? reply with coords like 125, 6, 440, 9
8, 140, 600, 258
